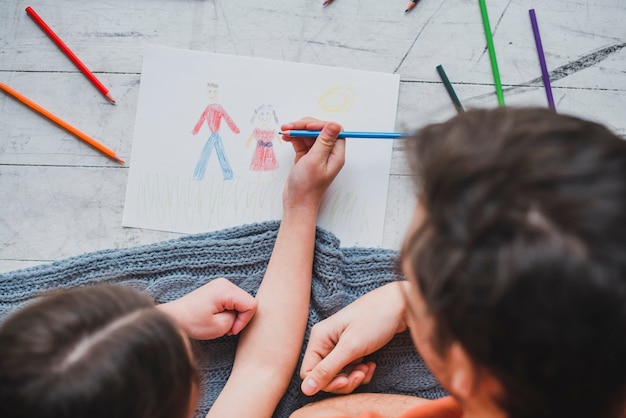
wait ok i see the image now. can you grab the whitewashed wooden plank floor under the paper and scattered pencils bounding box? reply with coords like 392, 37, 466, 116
0, 0, 626, 271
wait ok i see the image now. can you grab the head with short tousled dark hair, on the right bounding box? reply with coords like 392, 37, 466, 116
405, 108, 626, 418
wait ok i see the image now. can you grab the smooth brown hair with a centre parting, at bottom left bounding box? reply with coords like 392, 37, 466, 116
0, 286, 198, 418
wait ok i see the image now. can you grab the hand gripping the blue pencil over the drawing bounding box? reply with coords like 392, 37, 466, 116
281, 118, 345, 210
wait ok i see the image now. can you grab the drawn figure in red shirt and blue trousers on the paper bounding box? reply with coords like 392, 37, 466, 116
191, 83, 239, 180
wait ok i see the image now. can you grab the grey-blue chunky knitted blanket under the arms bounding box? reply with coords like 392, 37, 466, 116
0, 221, 445, 418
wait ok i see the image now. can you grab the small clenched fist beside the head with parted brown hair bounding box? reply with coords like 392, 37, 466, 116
158, 278, 257, 340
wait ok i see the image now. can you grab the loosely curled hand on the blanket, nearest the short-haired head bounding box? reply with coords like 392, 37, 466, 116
300, 282, 407, 396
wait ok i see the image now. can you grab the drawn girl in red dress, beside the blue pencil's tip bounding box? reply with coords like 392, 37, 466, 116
246, 104, 280, 171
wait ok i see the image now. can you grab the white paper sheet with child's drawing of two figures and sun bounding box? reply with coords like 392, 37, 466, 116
123, 47, 400, 246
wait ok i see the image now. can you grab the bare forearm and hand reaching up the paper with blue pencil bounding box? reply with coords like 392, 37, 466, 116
207, 120, 345, 418
